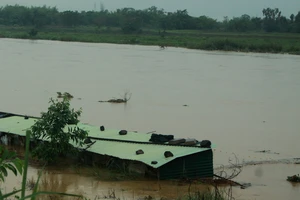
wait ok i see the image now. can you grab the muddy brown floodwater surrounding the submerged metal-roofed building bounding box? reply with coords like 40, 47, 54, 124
0, 39, 300, 199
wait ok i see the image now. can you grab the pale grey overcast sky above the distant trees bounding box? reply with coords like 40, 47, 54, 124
0, 0, 300, 20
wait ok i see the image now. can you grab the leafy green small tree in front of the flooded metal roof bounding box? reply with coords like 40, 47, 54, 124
32, 97, 87, 163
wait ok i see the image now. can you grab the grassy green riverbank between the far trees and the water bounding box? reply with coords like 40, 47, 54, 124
0, 26, 300, 55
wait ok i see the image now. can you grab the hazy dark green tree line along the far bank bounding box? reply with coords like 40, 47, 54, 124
0, 5, 300, 33
